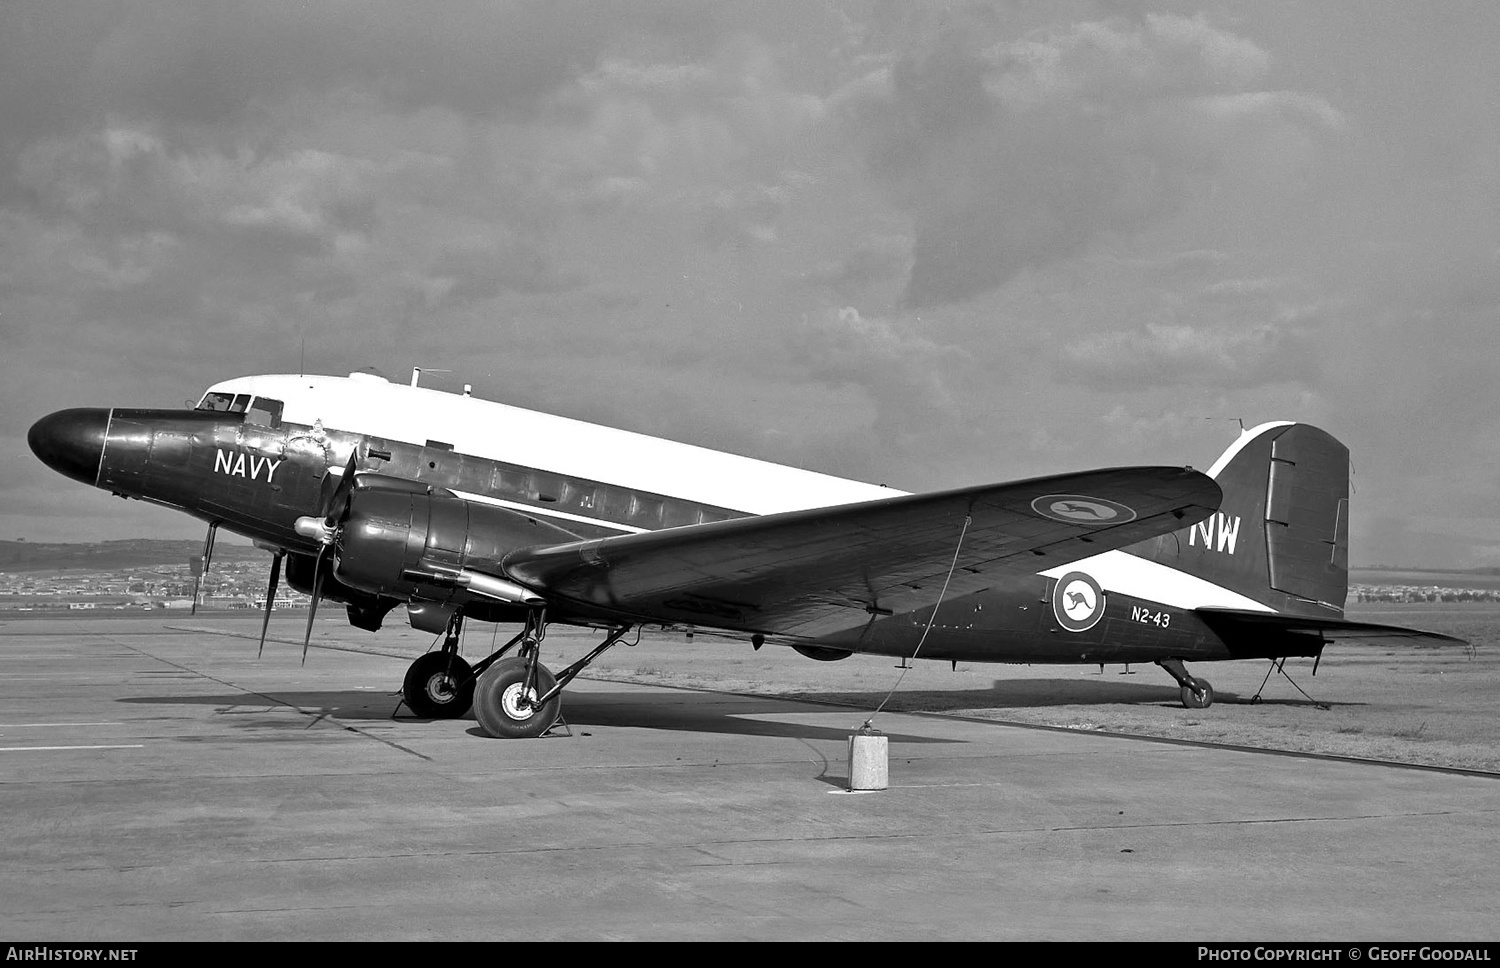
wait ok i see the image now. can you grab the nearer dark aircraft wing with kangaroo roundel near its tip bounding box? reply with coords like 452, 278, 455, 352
504, 467, 1223, 641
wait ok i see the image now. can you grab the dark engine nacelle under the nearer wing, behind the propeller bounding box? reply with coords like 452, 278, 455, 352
333, 479, 578, 605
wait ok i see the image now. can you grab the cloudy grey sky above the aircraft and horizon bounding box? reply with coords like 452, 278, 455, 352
0, 0, 1500, 566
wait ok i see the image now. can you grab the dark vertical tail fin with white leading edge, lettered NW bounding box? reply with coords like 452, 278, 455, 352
1131, 423, 1349, 617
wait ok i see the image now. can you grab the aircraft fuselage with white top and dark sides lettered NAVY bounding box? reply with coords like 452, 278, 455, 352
20, 377, 1322, 663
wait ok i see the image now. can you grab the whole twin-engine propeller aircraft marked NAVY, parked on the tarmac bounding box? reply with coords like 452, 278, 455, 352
27, 374, 1446, 737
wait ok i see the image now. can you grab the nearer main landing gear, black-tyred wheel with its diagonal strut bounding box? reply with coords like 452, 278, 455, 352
474, 609, 630, 740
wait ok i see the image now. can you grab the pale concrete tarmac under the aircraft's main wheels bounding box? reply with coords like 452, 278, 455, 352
0, 615, 1500, 942
